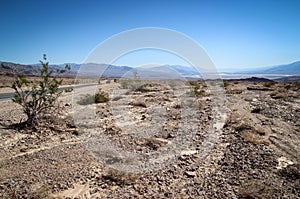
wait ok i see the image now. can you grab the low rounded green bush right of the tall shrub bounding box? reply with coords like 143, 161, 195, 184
77, 88, 109, 105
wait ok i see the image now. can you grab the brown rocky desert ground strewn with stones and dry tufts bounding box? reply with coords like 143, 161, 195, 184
0, 81, 300, 198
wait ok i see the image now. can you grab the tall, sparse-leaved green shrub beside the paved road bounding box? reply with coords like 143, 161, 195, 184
12, 54, 71, 126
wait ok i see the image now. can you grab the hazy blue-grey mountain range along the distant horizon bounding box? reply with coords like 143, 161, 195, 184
0, 61, 300, 78
